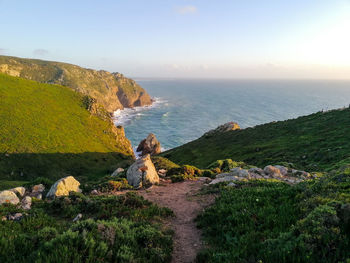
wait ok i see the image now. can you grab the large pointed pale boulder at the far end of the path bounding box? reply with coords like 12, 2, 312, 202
126, 154, 159, 188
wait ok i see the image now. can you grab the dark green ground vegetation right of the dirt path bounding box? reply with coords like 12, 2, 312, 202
197, 173, 350, 262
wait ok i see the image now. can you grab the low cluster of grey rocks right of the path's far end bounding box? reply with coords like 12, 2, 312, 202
210, 165, 313, 184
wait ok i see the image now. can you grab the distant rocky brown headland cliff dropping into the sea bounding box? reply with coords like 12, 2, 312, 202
0, 56, 152, 112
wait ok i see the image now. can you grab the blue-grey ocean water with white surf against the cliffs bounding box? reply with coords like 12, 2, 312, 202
115, 79, 350, 152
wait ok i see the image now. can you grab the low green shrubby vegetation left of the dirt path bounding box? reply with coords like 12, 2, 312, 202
0, 193, 172, 263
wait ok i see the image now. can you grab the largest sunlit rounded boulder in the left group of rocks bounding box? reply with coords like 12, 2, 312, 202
46, 176, 81, 198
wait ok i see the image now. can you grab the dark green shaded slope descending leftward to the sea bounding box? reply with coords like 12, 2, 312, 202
161, 109, 350, 171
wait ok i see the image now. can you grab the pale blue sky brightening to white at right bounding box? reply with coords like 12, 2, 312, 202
0, 0, 350, 79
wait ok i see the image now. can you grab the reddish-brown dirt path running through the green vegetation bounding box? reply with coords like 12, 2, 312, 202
138, 178, 214, 263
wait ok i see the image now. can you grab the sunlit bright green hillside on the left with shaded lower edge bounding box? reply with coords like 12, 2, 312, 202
0, 74, 132, 186
